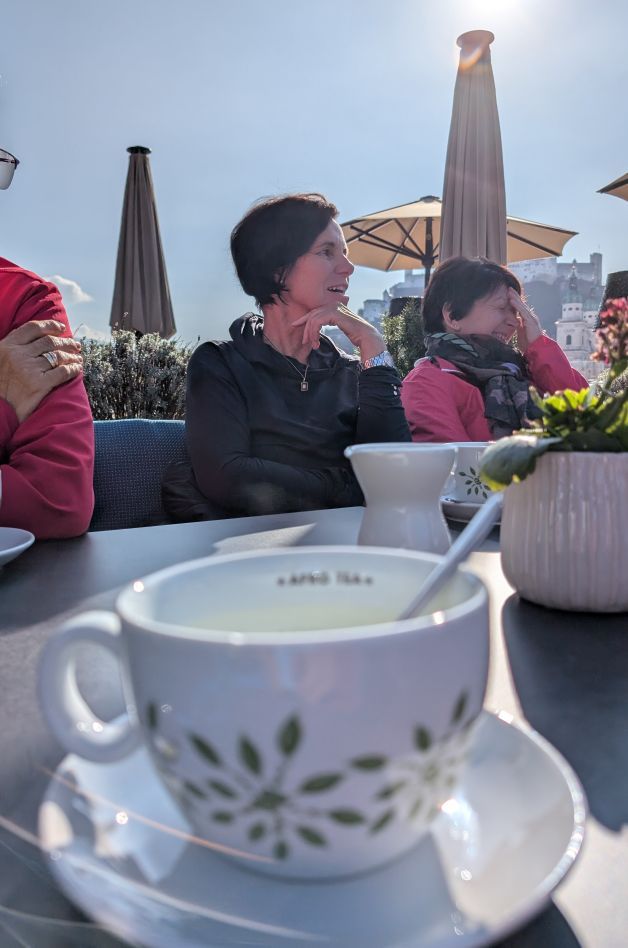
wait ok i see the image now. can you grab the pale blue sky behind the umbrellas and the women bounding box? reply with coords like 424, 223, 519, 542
0, 0, 628, 341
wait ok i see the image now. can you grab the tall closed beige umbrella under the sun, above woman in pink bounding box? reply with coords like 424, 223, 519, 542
440, 30, 507, 263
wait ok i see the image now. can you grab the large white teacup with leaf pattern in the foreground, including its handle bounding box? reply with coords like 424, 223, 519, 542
39, 547, 489, 878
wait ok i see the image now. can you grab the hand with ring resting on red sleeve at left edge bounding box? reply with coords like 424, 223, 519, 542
0, 319, 83, 423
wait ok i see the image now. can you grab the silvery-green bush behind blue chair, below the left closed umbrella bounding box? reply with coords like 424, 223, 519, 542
82, 330, 193, 421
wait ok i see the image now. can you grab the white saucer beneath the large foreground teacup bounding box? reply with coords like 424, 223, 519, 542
39, 712, 586, 948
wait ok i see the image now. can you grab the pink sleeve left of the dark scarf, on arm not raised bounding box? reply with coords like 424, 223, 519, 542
401, 363, 474, 442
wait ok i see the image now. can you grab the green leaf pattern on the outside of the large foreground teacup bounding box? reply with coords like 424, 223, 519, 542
144, 692, 472, 860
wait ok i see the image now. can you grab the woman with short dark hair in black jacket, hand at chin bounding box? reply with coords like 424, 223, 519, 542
165, 194, 410, 519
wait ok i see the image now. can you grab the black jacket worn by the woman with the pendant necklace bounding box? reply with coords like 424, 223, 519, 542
164, 314, 410, 519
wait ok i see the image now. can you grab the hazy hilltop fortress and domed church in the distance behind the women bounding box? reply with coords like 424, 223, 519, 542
344, 253, 604, 381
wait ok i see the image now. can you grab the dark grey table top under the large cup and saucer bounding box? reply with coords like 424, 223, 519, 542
0, 508, 628, 948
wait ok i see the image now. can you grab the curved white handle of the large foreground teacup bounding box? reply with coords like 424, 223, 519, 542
38, 611, 141, 763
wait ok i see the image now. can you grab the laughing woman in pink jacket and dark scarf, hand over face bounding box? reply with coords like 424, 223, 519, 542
401, 257, 588, 441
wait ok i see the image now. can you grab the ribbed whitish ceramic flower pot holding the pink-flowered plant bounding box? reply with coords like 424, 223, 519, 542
501, 452, 628, 612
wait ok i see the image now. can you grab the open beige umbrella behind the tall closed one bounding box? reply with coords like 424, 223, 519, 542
341, 195, 576, 285
